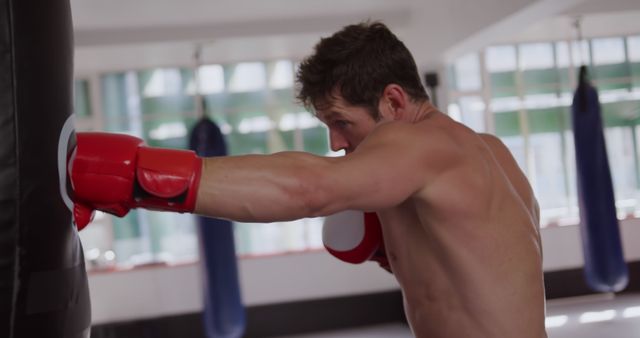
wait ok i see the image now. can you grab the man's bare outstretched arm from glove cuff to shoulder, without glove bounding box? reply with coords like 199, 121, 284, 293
195, 122, 434, 222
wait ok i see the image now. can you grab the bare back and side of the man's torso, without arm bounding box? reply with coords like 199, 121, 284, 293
380, 114, 546, 338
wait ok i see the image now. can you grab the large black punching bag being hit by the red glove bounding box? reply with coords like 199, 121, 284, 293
0, 0, 91, 338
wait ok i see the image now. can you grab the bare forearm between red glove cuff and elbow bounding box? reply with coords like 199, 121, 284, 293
194, 152, 334, 222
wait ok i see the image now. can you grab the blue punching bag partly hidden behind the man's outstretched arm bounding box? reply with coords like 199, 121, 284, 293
189, 118, 245, 338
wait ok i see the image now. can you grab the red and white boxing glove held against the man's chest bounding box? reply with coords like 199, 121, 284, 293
322, 210, 391, 272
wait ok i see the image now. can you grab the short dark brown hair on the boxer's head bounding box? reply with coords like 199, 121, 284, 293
296, 22, 429, 119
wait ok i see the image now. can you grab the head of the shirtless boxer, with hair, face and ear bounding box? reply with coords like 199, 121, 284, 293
297, 22, 429, 152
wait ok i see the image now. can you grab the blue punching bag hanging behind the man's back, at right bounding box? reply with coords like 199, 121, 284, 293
571, 66, 629, 292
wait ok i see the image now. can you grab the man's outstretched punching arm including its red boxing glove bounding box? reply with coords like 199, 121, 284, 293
69, 122, 457, 228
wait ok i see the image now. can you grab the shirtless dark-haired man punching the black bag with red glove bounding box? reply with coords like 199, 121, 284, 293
69, 23, 546, 338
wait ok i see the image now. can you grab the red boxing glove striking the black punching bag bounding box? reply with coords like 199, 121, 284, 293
68, 133, 202, 230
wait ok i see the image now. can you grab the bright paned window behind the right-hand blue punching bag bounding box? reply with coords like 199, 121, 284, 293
448, 35, 640, 226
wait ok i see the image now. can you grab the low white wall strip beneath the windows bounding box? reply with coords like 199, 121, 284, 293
89, 219, 640, 325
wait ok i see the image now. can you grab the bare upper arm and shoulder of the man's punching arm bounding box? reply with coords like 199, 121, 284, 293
323, 117, 464, 210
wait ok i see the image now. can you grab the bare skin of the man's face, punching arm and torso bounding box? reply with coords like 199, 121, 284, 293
196, 84, 546, 338
